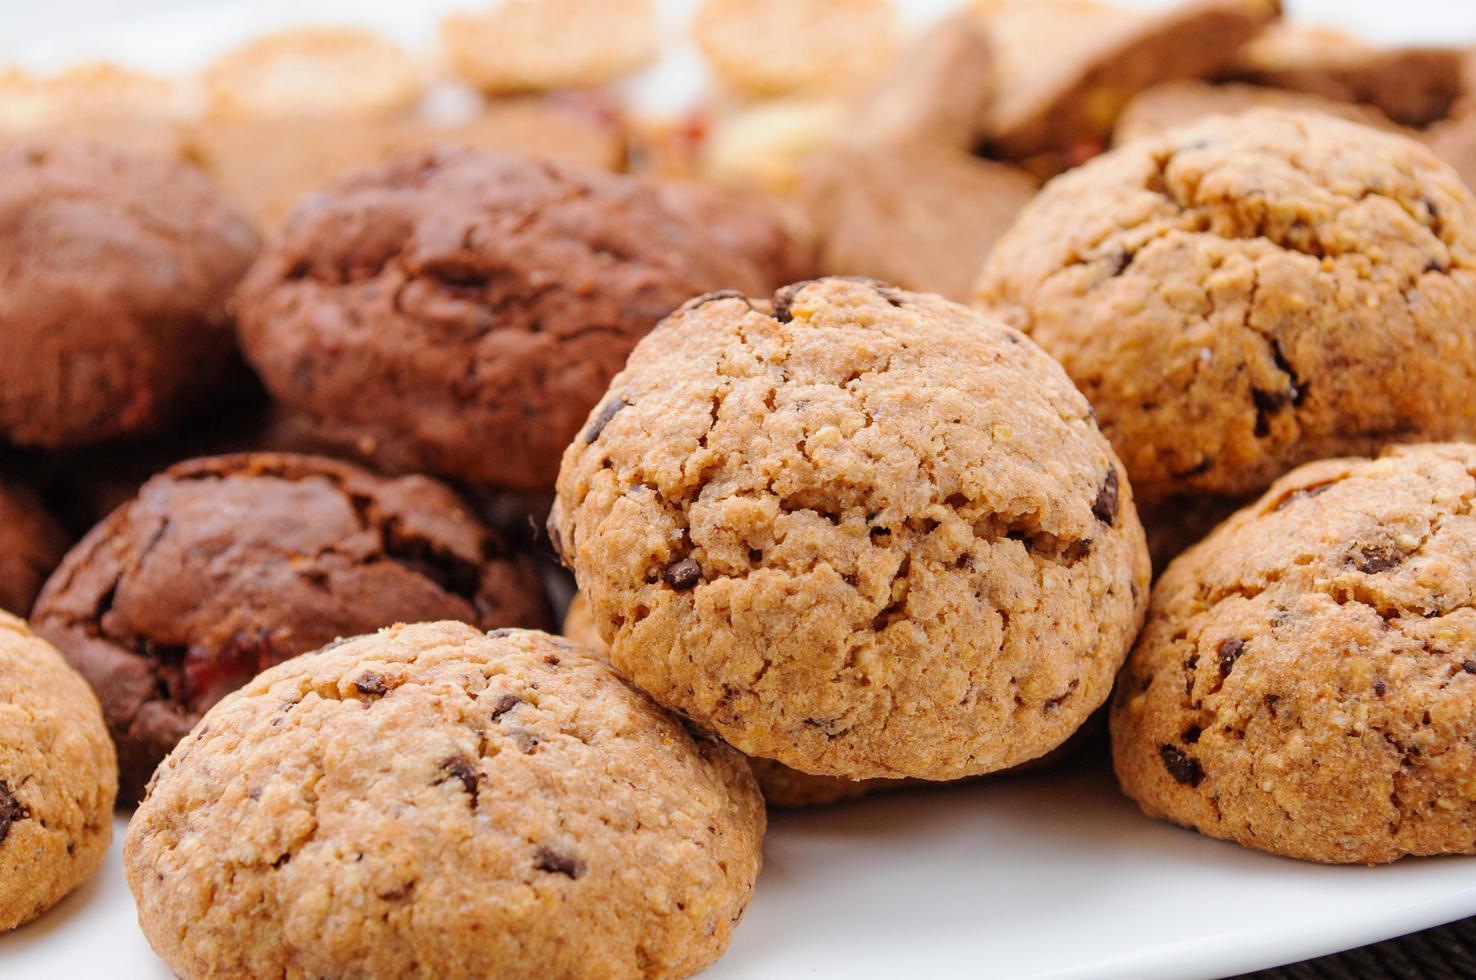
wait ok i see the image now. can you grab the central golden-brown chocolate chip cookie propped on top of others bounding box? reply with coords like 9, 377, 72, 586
549, 279, 1148, 779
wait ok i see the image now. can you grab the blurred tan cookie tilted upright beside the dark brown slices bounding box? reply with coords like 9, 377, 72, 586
847, 10, 996, 152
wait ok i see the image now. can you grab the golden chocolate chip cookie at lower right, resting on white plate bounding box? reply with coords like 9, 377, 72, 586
1111, 444, 1476, 865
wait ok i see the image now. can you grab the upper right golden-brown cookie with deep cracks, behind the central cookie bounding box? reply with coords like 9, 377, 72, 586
976, 109, 1476, 502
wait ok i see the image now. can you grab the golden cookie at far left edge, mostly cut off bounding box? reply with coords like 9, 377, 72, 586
0, 611, 118, 931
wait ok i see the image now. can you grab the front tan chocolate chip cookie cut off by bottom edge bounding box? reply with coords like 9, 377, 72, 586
124, 623, 765, 980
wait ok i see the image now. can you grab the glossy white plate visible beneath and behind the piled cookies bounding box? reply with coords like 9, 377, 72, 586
0, 0, 1476, 980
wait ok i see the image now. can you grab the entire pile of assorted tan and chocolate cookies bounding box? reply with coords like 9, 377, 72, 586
0, 0, 1476, 977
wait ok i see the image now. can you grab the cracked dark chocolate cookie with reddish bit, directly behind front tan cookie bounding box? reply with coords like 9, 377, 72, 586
32, 453, 548, 801
